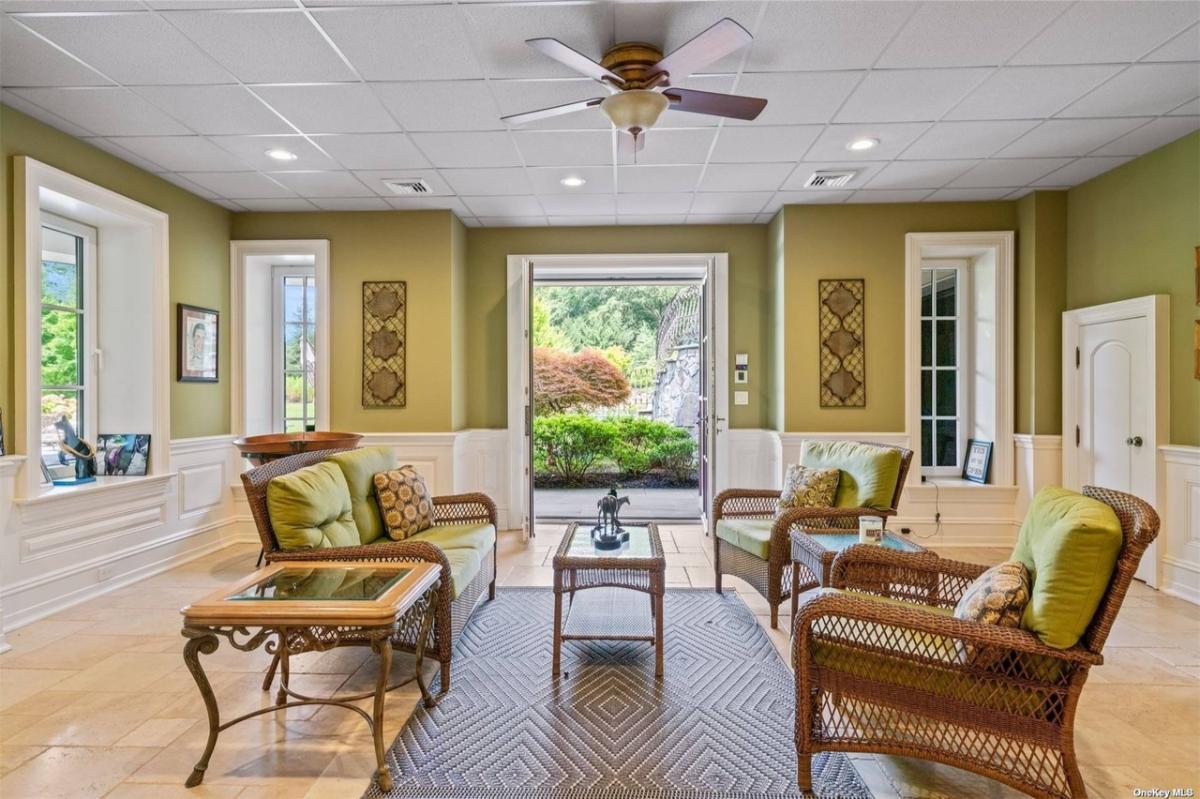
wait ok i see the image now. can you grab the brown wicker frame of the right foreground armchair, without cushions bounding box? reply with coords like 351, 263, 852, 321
792, 486, 1158, 799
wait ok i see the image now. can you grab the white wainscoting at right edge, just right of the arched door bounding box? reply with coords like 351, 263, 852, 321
1158, 444, 1200, 605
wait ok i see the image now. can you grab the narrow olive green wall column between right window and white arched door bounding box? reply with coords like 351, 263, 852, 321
1014, 192, 1067, 435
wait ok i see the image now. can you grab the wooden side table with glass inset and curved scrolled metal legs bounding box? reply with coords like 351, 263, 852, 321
180, 561, 439, 792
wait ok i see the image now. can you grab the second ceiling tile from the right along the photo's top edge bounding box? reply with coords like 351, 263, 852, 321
875, 0, 1070, 70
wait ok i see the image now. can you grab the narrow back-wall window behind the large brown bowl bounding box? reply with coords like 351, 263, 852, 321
272, 266, 317, 433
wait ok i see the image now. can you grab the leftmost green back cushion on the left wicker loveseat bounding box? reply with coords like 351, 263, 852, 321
266, 462, 359, 549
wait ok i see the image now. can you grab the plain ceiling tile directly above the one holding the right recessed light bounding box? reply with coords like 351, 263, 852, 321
836, 68, 990, 122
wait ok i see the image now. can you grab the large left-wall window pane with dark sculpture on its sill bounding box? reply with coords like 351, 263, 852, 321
38, 214, 96, 479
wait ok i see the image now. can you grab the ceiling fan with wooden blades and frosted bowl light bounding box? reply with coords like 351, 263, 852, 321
502, 17, 767, 152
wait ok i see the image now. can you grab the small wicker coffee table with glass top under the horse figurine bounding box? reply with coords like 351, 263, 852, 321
552, 522, 667, 678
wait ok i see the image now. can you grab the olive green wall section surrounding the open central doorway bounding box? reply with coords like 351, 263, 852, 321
467, 224, 772, 427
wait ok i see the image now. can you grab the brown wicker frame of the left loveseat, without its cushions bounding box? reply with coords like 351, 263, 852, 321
241, 450, 499, 691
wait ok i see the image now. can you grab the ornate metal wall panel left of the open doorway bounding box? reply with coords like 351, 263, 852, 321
362, 281, 408, 408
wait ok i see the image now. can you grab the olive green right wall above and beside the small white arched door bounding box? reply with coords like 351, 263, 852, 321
1067, 132, 1200, 446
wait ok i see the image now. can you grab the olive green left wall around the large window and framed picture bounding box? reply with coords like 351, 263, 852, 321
0, 106, 232, 438
